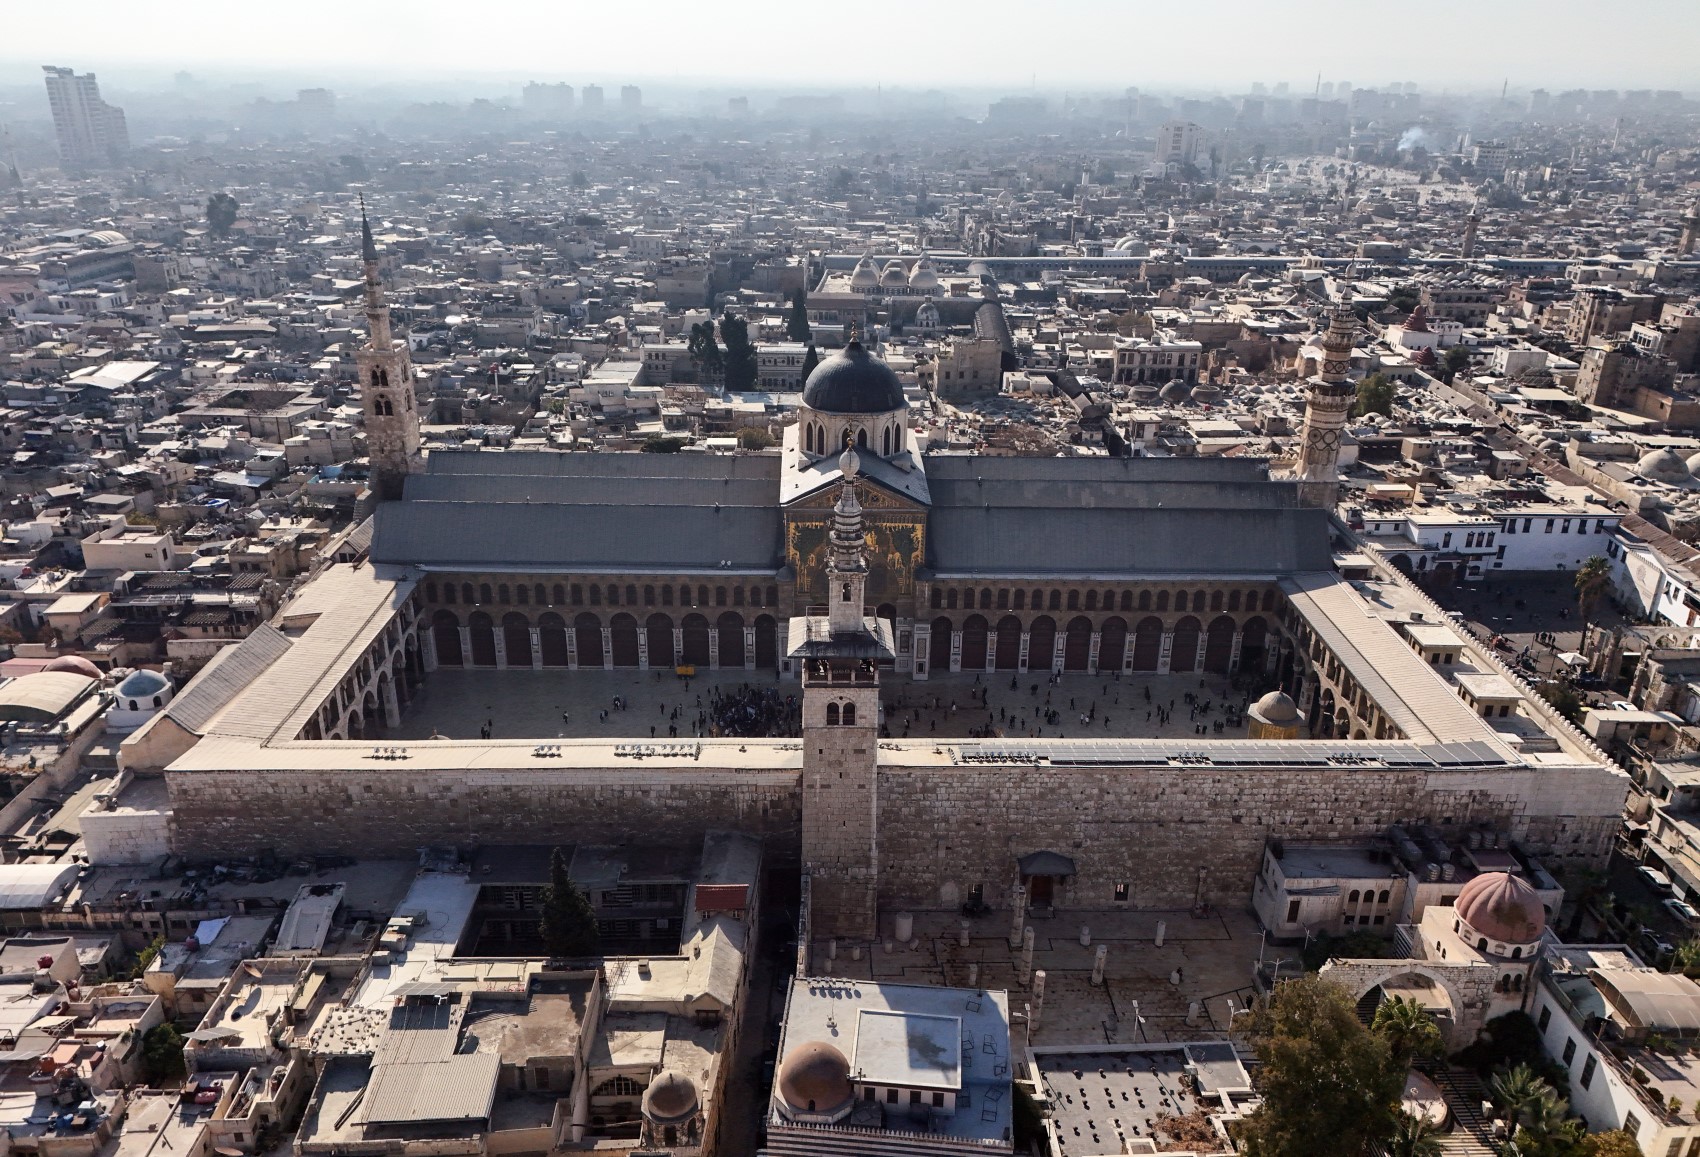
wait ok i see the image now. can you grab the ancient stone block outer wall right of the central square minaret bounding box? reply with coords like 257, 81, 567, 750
879, 768, 1627, 911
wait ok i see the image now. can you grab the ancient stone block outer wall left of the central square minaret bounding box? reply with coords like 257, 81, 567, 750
165, 768, 801, 858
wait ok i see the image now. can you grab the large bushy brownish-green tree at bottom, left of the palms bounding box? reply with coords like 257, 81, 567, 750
1241, 975, 1404, 1157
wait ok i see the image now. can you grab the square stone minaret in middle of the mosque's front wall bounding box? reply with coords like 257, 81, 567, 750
791, 447, 893, 940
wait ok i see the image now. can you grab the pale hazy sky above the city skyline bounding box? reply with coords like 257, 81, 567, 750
0, 0, 1700, 92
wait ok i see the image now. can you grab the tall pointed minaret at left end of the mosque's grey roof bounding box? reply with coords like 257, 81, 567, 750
354, 197, 425, 501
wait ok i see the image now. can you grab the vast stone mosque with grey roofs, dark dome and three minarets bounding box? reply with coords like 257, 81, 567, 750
124, 222, 1627, 938
